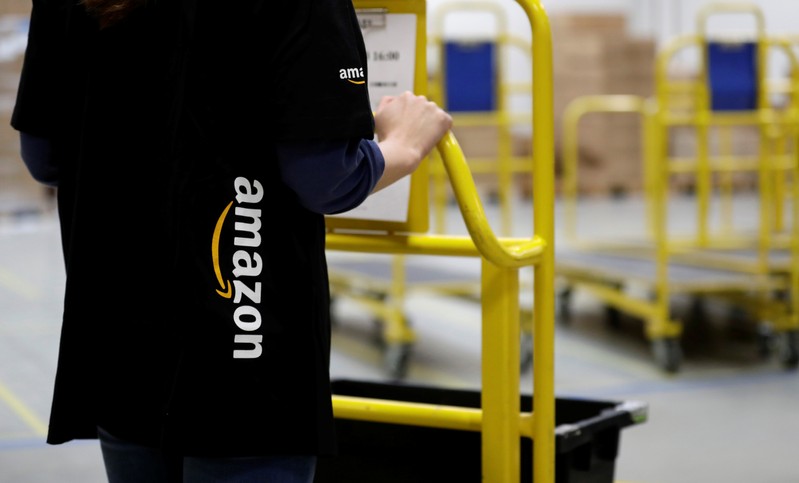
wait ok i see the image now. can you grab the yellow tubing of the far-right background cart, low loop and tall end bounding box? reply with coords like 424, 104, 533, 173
563, 3, 799, 350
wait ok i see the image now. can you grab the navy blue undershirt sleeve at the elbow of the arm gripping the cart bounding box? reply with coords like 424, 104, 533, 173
277, 139, 385, 214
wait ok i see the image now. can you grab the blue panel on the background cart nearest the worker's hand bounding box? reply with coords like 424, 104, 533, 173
444, 42, 496, 112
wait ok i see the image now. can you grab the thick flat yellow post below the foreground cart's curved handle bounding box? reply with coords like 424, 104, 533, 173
481, 259, 521, 483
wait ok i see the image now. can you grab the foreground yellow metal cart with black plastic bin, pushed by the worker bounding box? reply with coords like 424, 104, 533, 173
316, 0, 646, 483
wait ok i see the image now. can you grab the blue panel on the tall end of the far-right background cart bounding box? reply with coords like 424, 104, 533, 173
707, 42, 758, 111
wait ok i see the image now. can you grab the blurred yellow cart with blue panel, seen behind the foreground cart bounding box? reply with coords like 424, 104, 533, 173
329, 1, 535, 380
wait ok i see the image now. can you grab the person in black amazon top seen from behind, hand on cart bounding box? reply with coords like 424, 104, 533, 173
12, 0, 452, 482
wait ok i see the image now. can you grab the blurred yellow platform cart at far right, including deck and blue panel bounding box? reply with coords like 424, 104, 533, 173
556, 3, 799, 371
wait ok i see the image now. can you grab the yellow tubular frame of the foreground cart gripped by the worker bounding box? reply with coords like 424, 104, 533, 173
327, 0, 555, 483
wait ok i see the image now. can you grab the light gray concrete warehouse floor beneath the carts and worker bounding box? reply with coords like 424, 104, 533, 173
0, 199, 799, 483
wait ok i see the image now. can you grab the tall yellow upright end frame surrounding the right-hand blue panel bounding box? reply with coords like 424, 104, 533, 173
655, 2, 799, 255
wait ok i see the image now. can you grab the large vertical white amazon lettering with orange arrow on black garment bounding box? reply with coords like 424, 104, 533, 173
211, 177, 263, 359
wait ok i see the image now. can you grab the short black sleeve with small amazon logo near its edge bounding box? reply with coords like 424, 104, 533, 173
269, 0, 374, 142
